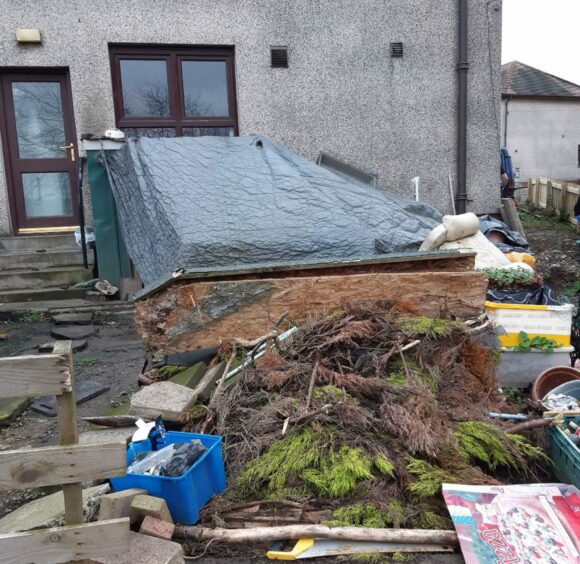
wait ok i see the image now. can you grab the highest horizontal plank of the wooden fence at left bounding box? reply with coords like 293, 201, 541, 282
0, 354, 72, 398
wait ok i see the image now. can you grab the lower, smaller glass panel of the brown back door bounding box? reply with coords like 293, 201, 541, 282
22, 172, 73, 217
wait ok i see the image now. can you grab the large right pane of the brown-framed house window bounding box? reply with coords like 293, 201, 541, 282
181, 61, 230, 117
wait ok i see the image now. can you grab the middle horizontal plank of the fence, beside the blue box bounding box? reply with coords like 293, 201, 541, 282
0, 441, 126, 490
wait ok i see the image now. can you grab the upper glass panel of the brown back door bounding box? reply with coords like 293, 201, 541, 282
12, 82, 68, 159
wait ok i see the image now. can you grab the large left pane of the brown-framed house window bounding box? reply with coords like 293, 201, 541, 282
120, 59, 169, 117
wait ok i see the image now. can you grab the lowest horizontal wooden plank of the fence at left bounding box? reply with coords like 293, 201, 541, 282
0, 518, 130, 564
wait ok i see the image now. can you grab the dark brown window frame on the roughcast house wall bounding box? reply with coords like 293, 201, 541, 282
109, 45, 239, 137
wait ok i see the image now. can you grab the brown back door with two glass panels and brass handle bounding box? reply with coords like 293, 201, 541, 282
0, 71, 78, 234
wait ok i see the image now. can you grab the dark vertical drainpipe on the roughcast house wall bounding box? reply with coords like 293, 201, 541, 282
455, 0, 469, 213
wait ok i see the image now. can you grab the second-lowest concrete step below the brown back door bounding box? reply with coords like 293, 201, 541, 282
0, 266, 92, 290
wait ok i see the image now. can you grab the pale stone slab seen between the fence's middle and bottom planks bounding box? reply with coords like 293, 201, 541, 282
0, 484, 110, 532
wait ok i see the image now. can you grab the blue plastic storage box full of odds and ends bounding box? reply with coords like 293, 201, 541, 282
110, 431, 226, 525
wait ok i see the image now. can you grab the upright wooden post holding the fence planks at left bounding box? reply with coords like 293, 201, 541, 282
53, 341, 85, 525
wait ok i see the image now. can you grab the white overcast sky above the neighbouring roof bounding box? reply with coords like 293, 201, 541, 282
501, 0, 580, 84
